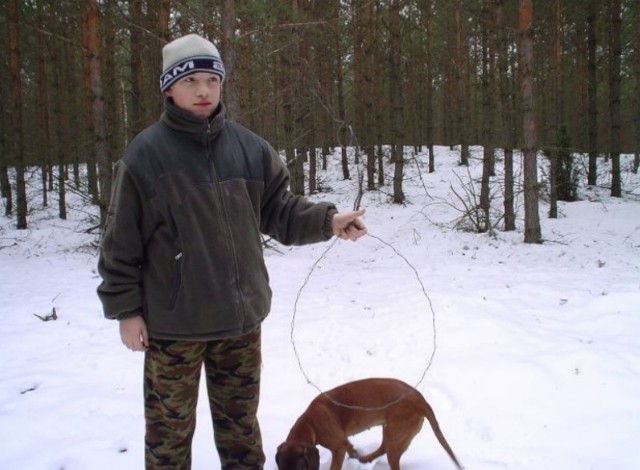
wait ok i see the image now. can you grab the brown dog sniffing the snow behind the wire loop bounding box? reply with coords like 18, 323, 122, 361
276, 379, 462, 470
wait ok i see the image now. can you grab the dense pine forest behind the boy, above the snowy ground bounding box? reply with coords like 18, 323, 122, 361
0, 0, 640, 242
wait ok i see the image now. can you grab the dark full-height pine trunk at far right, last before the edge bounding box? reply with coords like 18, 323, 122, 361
609, 0, 622, 197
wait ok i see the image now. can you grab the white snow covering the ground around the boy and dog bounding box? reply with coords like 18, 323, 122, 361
0, 147, 640, 470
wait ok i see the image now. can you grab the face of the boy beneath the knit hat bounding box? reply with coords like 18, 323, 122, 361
165, 72, 222, 118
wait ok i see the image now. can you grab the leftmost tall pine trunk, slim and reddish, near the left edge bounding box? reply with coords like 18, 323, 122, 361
7, 0, 28, 230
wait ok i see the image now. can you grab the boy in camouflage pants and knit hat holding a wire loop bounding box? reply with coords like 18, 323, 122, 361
98, 34, 366, 469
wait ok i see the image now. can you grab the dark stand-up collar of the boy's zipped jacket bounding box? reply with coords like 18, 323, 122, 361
160, 98, 226, 141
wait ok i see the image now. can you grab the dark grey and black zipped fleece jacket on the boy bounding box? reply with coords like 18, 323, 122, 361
98, 99, 336, 340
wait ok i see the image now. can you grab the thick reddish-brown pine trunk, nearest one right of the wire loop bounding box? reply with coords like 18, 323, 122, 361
518, 0, 542, 243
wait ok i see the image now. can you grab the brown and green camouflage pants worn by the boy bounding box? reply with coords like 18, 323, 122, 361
144, 328, 265, 470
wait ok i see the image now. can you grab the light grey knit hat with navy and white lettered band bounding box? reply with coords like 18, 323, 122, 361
160, 34, 224, 91
